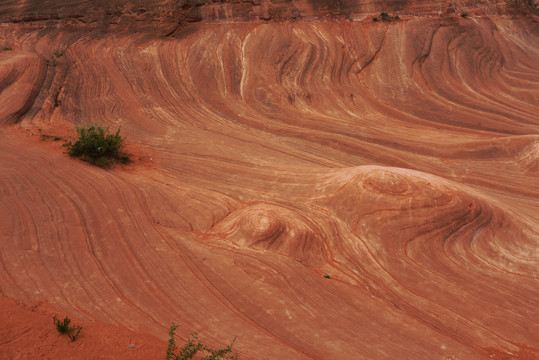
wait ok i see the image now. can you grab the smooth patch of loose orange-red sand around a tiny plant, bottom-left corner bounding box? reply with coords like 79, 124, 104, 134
0, 297, 167, 359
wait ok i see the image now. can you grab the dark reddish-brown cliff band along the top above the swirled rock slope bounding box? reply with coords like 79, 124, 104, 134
0, 0, 534, 25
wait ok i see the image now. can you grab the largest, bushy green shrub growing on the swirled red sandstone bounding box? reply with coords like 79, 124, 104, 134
64, 125, 130, 166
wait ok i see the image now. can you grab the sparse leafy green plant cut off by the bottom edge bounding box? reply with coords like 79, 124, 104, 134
165, 323, 239, 360
